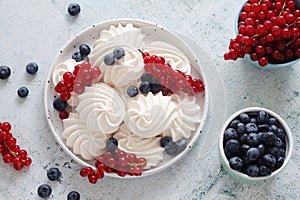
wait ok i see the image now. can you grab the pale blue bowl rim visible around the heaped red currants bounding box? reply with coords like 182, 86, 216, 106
234, 0, 300, 69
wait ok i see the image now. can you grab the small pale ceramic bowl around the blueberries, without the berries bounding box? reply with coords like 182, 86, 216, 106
219, 107, 293, 183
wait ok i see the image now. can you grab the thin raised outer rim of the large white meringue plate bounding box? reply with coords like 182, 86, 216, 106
44, 18, 209, 179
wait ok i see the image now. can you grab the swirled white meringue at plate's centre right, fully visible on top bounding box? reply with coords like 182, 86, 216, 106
124, 92, 177, 138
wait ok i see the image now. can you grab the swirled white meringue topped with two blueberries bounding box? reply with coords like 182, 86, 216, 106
90, 41, 144, 87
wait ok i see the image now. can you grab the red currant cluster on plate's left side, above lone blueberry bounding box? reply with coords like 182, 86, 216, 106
54, 62, 101, 119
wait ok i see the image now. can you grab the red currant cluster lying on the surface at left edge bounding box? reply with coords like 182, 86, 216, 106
0, 122, 32, 170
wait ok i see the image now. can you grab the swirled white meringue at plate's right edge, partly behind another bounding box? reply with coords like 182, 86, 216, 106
163, 94, 201, 142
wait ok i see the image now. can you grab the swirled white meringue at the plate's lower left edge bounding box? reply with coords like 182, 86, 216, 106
62, 113, 106, 160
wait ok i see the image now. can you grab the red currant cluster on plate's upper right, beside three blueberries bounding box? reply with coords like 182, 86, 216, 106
142, 52, 204, 95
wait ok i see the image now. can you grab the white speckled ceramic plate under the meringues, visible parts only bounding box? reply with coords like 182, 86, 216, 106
44, 19, 208, 178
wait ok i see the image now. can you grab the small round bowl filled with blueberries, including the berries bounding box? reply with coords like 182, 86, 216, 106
219, 107, 293, 182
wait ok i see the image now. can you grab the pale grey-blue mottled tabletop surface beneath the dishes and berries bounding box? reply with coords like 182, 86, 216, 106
0, 0, 300, 200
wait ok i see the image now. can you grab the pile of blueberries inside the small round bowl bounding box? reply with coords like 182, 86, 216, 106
223, 111, 286, 177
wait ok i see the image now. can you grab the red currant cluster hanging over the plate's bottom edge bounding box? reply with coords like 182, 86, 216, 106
80, 149, 147, 184
